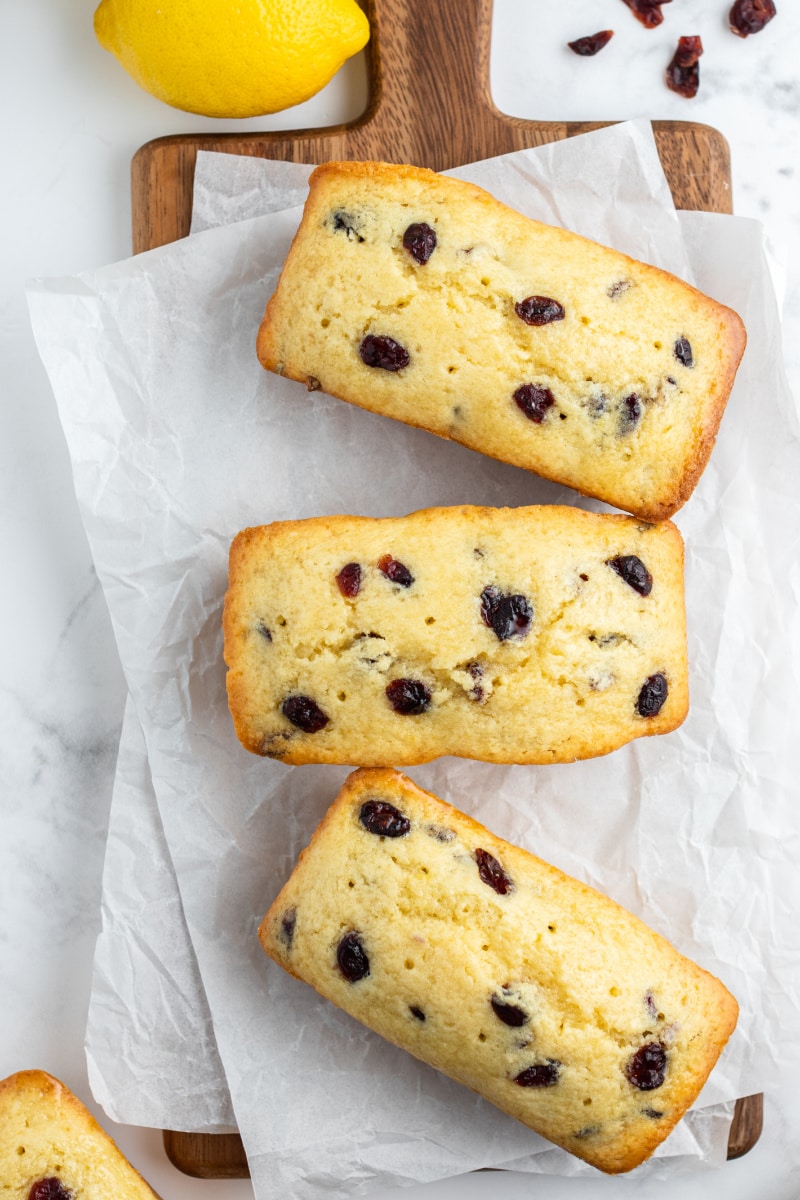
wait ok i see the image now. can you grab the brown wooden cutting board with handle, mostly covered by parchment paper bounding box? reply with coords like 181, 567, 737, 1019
131, 0, 763, 1178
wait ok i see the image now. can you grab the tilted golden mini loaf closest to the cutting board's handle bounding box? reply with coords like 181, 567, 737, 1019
258, 162, 745, 520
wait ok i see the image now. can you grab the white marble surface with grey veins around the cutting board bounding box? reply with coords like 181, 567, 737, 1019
0, 0, 800, 1200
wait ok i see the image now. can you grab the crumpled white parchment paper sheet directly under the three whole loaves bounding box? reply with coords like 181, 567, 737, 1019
30, 121, 799, 1195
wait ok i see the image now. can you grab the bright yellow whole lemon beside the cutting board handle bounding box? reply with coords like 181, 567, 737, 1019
95, 0, 369, 116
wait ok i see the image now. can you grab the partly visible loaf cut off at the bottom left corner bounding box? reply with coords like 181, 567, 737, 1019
0, 1070, 158, 1200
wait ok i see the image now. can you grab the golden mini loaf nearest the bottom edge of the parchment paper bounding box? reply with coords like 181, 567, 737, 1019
259, 769, 738, 1172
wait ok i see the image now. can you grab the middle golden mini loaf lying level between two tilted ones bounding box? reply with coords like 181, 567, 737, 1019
224, 506, 687, 767
